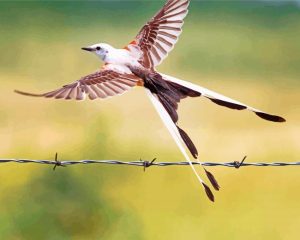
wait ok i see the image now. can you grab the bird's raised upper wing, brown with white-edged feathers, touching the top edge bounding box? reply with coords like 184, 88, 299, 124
128, 0, 190, 68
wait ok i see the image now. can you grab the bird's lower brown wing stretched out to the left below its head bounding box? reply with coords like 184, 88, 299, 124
15, 70, 139, 100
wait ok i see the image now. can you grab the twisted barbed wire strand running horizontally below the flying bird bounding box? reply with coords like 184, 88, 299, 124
0, 153, 300, 171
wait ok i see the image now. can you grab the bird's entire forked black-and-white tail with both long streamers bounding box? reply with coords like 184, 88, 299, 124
145, 73, 285, 201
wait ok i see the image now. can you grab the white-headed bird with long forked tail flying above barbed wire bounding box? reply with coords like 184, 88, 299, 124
15, 0, 285, 201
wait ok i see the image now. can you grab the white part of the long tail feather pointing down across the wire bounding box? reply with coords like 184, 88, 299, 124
146, 89, 204, 186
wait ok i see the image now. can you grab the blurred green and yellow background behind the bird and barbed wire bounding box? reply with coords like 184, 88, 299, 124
0, 0, 300, 240
